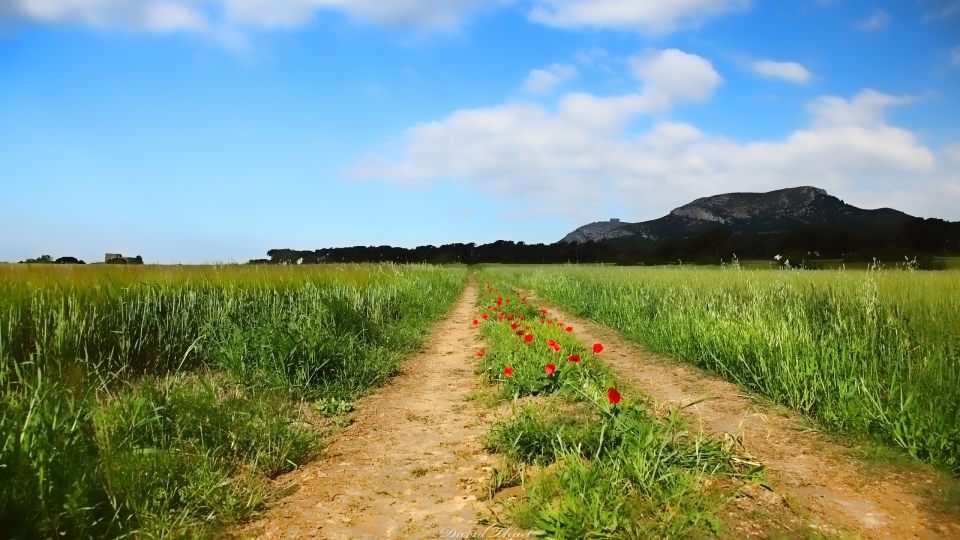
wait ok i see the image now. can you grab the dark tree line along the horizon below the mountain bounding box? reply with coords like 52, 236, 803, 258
250, 218, 960, 265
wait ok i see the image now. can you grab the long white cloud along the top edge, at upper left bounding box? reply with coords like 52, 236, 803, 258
0, 0, 514, 32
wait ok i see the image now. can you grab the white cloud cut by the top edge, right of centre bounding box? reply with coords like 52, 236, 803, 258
530, 0, 751, 34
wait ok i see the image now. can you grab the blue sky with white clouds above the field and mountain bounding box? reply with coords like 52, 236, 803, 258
0, 0, 960, 263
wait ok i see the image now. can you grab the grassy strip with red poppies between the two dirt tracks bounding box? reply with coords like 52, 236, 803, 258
473, 278, 780, 539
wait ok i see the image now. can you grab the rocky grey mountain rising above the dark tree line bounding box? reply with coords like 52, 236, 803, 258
561, 186, 913, 243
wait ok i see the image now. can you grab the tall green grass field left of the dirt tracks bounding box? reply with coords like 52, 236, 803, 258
0, 265, 466, 538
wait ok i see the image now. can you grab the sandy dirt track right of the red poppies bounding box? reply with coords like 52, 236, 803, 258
530, 294, 960, 539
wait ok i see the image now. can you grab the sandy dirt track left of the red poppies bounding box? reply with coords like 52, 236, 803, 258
243, 282, 502, 539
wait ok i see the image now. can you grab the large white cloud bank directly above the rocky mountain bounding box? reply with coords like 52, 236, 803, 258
344, 84, 960, 220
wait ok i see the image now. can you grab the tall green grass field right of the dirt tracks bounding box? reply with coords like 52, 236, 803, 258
487, 266, 960, 474
